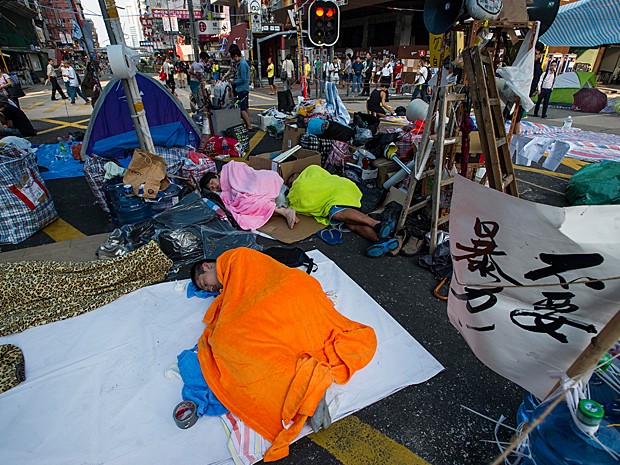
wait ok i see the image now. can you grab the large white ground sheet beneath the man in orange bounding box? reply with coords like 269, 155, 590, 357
0, 251, 443, 465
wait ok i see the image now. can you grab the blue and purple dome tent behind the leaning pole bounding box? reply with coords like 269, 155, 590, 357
82, 73, 200, 156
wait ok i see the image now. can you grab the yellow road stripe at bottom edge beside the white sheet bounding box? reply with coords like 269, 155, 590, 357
308, 415, 429, 465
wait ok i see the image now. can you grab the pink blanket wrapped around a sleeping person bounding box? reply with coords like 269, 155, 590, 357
220, 161, 284, 230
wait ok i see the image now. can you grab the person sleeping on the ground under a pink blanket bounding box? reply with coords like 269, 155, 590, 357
200, 161, 299, 231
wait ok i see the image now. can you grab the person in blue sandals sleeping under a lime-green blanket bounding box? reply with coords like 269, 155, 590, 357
287, 165, 398, 257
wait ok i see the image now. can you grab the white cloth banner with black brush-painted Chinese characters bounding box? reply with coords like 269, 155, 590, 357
448, 176, 620, 397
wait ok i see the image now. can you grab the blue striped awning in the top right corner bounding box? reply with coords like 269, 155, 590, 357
540, 0, 620, 47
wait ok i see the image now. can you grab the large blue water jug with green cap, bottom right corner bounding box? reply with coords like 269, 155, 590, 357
520, 399, 620, 465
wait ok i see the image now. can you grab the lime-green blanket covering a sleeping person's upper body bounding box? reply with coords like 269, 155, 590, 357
287, 165, 362, 225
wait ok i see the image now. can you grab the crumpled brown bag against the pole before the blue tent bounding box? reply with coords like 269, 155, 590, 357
123, 149, 170, 199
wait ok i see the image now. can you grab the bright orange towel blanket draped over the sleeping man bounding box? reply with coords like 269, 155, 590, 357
198, 248, 377, 462
